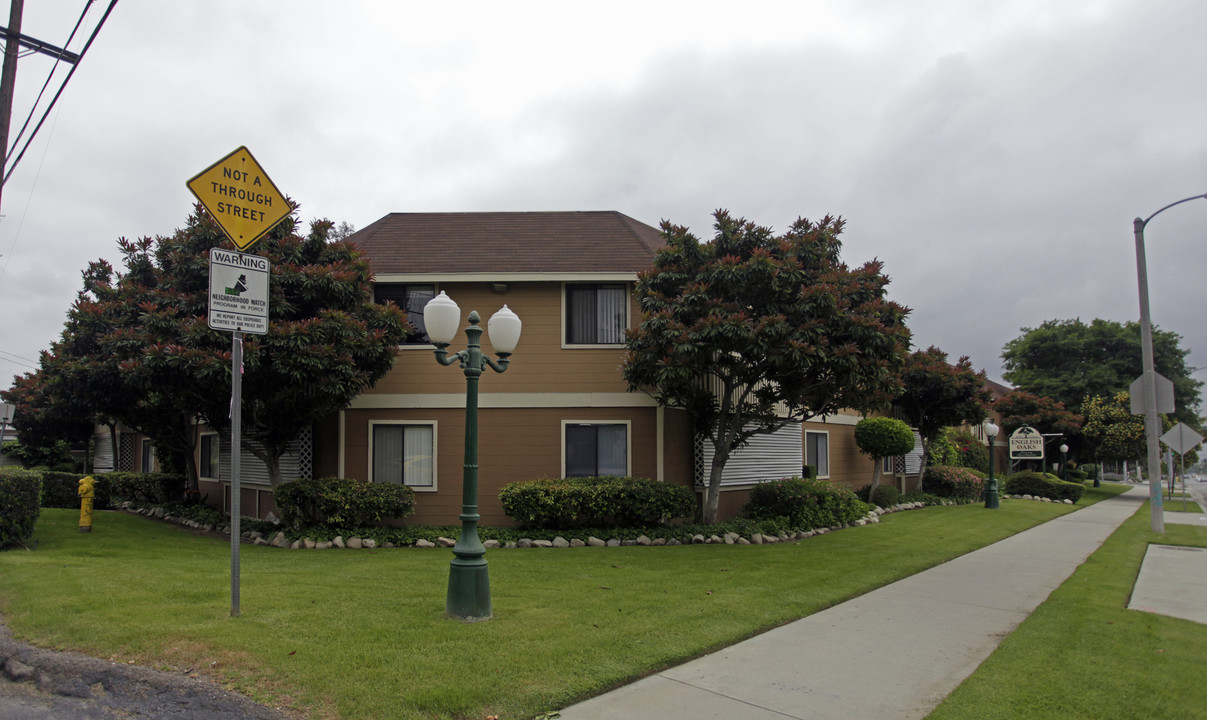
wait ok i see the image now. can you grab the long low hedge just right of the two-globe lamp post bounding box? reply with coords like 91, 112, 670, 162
498, 476, 695, 529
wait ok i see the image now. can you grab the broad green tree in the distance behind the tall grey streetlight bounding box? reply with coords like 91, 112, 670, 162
1002, 318, 1202, 427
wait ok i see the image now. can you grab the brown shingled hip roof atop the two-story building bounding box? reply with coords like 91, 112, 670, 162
349, 211, 663, 274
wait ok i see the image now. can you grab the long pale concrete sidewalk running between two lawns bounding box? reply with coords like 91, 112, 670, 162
561, 486, 1148, 720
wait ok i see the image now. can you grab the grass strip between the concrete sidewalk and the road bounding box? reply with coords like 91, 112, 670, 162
928, 496, 1207, 720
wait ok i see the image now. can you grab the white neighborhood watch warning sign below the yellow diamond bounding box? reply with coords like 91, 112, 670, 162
209, 247, 269, 335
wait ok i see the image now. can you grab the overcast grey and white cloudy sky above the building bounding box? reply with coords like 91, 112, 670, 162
0, 0, 1207, 393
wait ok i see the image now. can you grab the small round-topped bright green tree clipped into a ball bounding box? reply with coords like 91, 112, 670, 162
896, 345, 993, 490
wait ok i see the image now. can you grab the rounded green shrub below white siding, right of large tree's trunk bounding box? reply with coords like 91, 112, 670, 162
742, 478, 868, 529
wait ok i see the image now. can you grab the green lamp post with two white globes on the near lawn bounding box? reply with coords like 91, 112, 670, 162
424, 291, 521, 622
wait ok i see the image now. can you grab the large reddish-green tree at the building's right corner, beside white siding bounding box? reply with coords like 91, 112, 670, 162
623, 210, 909, 522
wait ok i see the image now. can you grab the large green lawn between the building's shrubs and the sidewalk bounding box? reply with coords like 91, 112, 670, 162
0, 486, 1125, 720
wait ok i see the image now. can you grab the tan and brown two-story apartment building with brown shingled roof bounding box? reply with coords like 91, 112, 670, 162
183, 211, 893, 525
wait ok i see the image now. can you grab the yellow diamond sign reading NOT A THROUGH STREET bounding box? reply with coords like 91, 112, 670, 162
188, 147, 290, 250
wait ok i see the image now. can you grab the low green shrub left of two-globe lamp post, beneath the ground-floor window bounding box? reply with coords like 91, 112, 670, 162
273, 478, 415, 529
